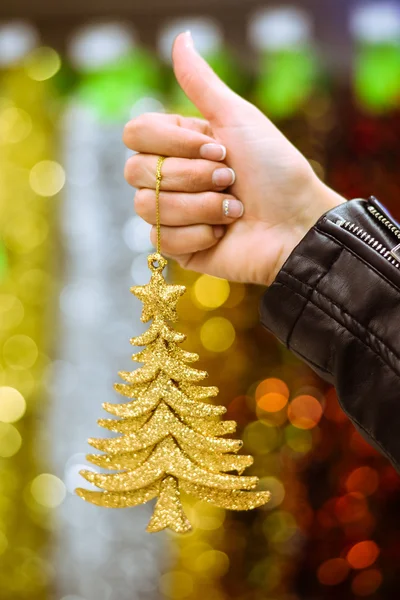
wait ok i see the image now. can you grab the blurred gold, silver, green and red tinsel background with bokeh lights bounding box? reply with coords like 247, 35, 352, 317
0, 0, 400, 600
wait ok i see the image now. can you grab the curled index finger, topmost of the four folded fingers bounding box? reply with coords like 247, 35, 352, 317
123, 113, 226, 160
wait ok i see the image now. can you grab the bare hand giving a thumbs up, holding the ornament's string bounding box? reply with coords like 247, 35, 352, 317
124, 33, 345, 285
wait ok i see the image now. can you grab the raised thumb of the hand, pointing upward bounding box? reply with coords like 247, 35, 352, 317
172, 31, 244, 126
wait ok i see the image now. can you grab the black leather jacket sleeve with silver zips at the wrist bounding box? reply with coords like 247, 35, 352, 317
260, 198, 400, 471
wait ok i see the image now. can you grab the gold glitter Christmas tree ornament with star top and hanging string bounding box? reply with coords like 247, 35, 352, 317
76, 157, 270, 533
